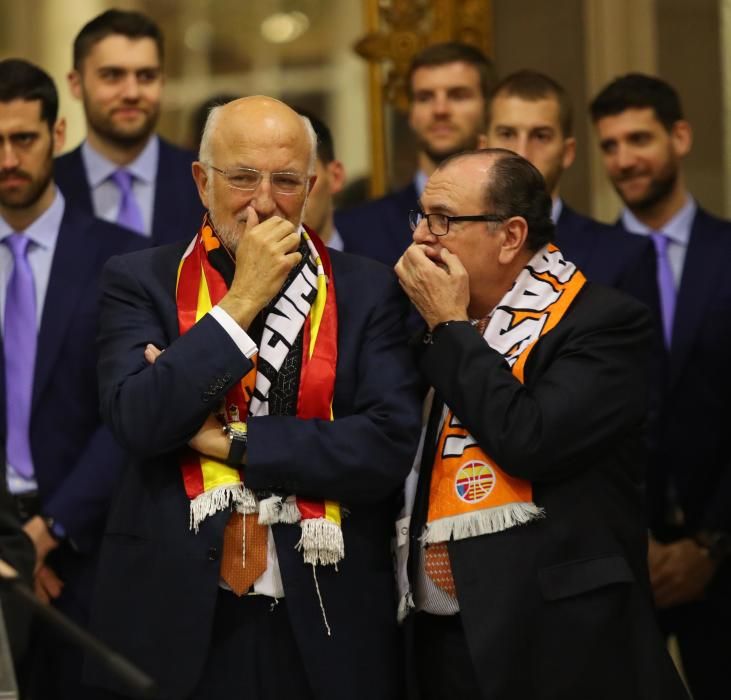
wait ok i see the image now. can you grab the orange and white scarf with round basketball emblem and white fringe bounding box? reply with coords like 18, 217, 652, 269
421, 245, 586, 544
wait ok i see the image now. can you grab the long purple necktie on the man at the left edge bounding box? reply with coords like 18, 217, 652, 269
3, 233, 37, 478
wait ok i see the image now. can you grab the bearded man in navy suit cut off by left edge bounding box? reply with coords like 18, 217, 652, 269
0, 59, 141, 698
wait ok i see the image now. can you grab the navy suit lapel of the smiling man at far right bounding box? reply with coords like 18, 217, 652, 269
670, 209, 726, 387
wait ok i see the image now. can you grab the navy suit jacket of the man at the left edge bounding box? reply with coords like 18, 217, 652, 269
0, 201, 145, 620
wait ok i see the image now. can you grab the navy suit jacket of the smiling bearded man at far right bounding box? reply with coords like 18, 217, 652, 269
617, 208, 731, 540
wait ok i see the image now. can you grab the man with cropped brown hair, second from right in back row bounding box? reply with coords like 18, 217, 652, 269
487, 70, 658, 309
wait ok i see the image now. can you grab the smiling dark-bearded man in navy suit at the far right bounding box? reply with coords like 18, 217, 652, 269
591, 74, 731, 700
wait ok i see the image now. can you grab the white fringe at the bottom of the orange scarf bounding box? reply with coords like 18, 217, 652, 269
419, 503, 545, 544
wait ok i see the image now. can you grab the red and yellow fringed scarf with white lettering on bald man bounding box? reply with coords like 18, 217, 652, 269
176, 218, 345, 565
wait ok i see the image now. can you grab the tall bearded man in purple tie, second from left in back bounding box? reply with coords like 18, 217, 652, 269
56, 10, 203, 244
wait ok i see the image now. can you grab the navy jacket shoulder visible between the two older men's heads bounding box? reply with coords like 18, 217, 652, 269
335, 182, 419, 267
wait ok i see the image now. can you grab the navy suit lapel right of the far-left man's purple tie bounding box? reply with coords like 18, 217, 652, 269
33, 206, 100, 406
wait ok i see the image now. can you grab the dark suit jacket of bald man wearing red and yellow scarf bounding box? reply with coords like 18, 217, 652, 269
90, 239, 420, 699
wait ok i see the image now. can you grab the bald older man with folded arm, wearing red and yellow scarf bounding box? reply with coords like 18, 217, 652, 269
83, 97, 420, 700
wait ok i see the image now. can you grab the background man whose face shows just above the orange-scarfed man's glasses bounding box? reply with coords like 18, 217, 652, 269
335, 42, 494, 265
